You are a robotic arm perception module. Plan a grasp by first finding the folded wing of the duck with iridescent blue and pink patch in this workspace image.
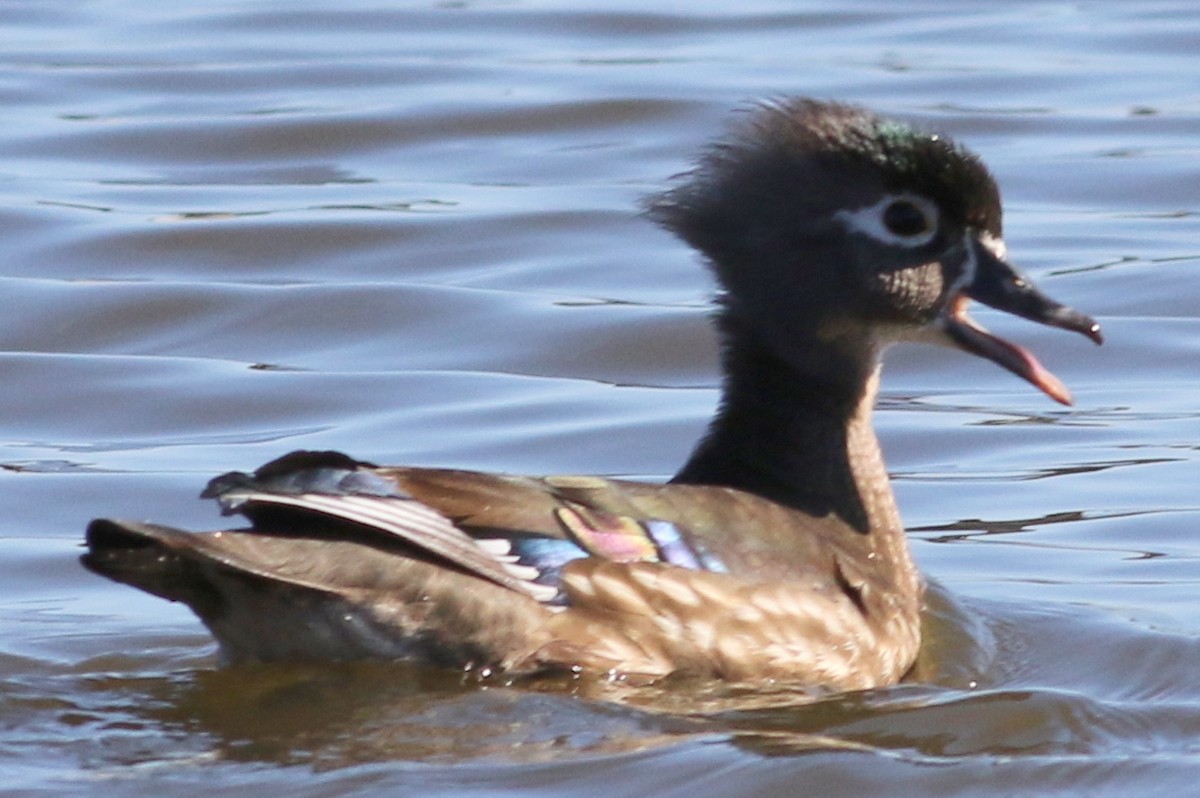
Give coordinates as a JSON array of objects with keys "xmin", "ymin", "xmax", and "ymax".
[{"xmin": 190, "ymin": 451, "xmax": 739, "ymax": 605}]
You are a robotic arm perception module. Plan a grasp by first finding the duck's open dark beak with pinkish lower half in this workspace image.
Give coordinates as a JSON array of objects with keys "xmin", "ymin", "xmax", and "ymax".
[{"xmin": 940, "ymin": 236, "xmax": 1104, "ymax": 404}]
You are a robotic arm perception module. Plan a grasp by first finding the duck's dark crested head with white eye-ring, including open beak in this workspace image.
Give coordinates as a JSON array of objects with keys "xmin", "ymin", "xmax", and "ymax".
[{"xmin": 650, "ymin": 100, "xmax": 1102, "ymax": 403}]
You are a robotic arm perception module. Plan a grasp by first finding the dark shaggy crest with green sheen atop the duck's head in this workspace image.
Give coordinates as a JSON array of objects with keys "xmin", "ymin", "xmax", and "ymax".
[{"xmin": 649, "ymin": 98, "xmax": 1002, "ymax": 273}]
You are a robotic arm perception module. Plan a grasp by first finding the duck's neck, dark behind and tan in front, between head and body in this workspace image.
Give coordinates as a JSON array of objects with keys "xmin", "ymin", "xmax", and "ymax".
[{"xmin": 672, "ymin": 313, "xmax": 902, "ymax": 534}]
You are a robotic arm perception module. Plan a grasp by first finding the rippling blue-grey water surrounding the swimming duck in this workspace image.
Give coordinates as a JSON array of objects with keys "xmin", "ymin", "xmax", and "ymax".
[{"xmin": 0, "ymin": 0, "xmax": 1200, "ymax": 798}]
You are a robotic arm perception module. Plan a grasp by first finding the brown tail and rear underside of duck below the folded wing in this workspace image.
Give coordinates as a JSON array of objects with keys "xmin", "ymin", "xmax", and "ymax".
[{"xmin": 82, "ymin": 518, "xmax": 551, "ymax": 668}]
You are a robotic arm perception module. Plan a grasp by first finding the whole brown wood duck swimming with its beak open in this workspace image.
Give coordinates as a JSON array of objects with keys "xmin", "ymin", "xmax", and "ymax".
[{"xmin": 83, "ymin": 98, "xmax": 1100, "ymax": 690}]
